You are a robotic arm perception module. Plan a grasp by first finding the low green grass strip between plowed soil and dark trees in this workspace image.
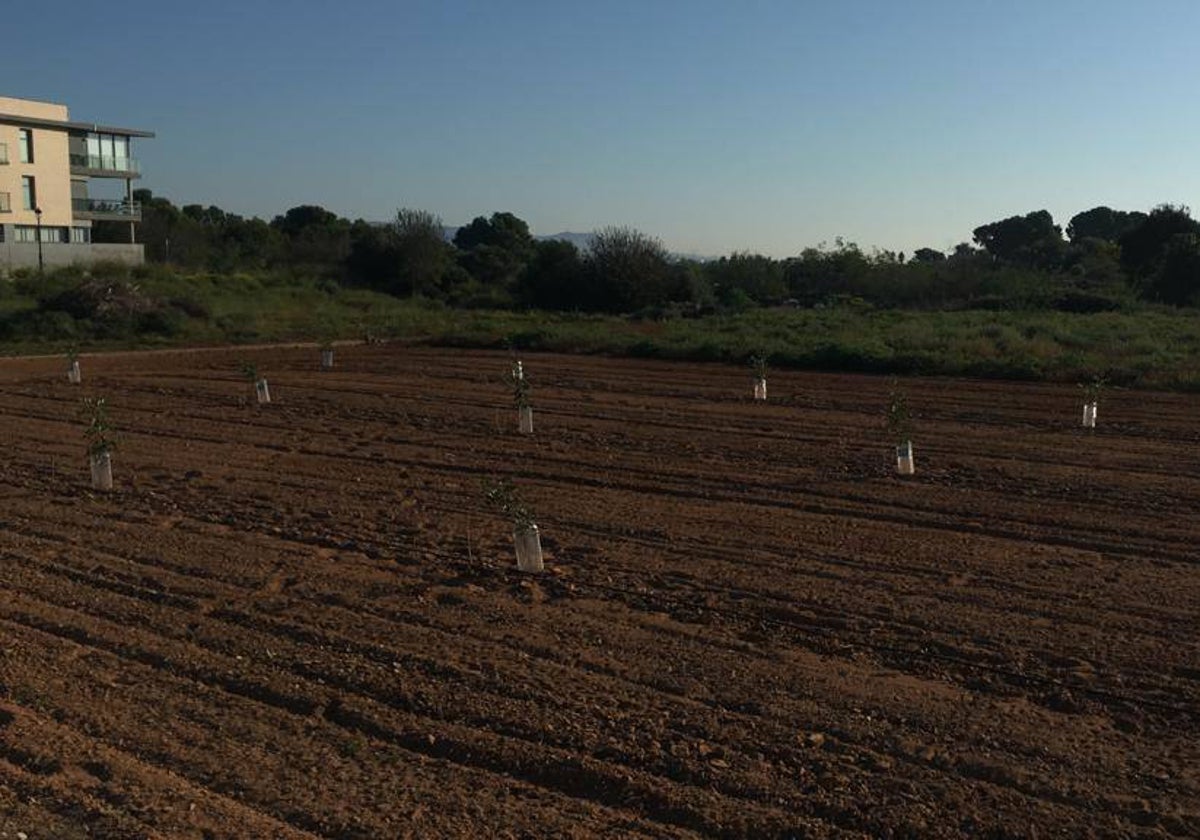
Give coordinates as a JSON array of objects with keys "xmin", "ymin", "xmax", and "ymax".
[{"xmin": 0, "ymin": 266, "xmax": 1200, "ymax": 390}]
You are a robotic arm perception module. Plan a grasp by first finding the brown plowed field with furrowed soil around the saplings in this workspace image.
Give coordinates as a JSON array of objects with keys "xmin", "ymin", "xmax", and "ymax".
[{"xmin": 0, "ymin": 344, "xmax": 1200, "ymax": 840}]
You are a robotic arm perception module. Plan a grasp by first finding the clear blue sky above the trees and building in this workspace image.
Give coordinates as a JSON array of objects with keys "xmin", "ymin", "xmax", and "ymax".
[{"xmin": 9, "ymin": 0, "xmax": 1200, "ymax": 257}]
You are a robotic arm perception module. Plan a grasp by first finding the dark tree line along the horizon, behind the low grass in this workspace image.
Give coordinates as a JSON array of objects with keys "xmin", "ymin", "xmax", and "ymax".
[{"xmin": 95, "ymin": 190, "xmax": 1200, "ymax": 316}]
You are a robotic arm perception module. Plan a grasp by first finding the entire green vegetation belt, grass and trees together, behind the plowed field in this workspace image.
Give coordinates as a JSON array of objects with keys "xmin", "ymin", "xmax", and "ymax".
[{"xmin": 7, "ymin": 191, "xmax": 1200, "ymax": 390}]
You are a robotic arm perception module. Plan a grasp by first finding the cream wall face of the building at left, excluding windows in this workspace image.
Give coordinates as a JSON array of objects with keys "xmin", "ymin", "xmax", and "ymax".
[{"xmin": 0, "ymin": 96, "xmax": 72, "ymax": 227}]
